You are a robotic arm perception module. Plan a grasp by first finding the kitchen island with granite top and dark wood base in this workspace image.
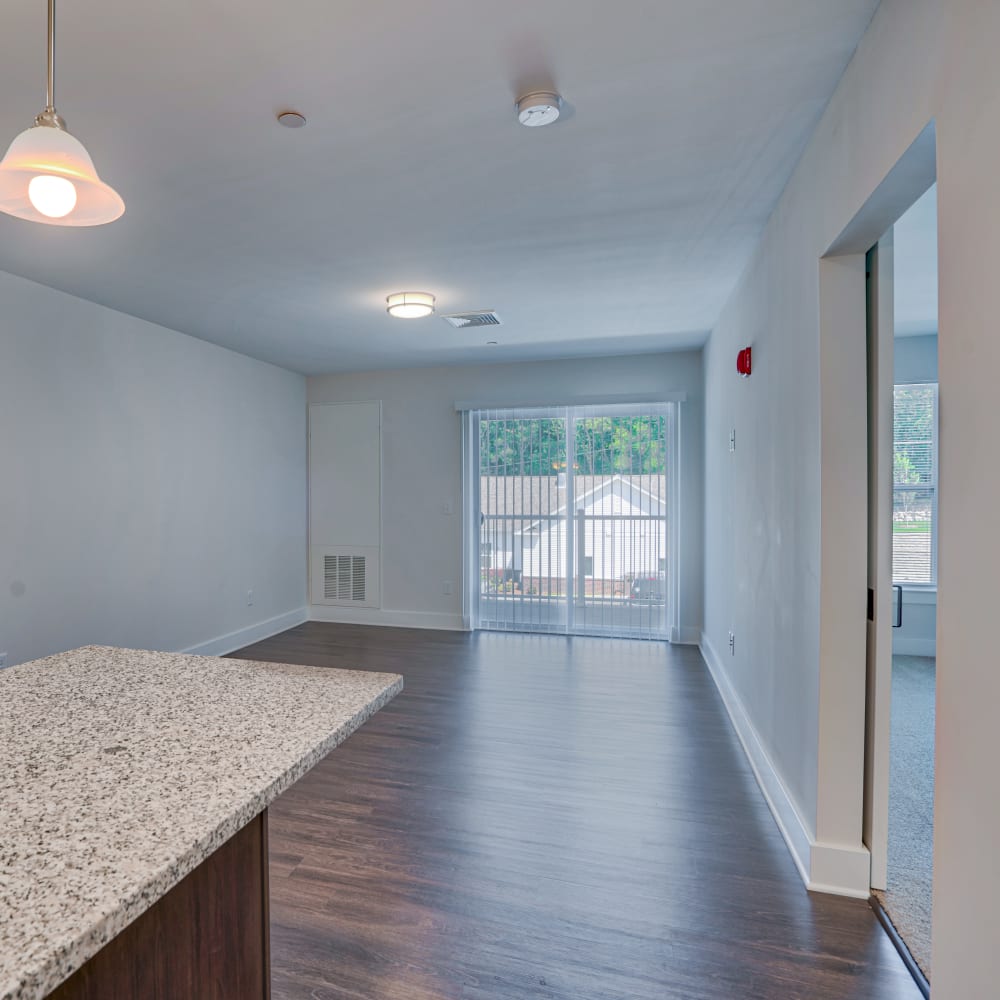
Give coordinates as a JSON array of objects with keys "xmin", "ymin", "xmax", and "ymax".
[{"xmin": 0, "ymin": 646, "xmax": 403, "ymax": 1000}]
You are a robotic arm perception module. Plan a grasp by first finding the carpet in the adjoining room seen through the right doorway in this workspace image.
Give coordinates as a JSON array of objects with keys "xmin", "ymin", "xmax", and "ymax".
[{"xmin": 875, "ymin": 656, "xmax": 935, "ymax": 980}]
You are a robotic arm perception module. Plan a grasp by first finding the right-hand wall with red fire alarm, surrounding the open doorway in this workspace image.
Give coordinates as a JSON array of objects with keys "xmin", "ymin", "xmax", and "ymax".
[{"xmin": 705, "ymin": 0, "xmax": 1000, "ymax": 998}]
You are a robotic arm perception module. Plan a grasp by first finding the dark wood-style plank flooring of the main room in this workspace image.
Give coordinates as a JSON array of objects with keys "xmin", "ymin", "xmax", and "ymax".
[{"xmin": 233, "ymin": 623, "xmax": 920, "ymax": 1000}]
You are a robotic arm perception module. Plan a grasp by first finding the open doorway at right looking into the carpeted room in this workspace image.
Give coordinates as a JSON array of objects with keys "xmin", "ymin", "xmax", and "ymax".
[{"xmin": 872, "ymin": 186, "xmax": 938, "ymax": 980}]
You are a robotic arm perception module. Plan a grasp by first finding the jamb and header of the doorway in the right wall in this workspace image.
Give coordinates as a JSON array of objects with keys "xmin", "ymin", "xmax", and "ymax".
[{"xmin": 809, "ymin": 122, "xmax": 936, "ymax": 897}]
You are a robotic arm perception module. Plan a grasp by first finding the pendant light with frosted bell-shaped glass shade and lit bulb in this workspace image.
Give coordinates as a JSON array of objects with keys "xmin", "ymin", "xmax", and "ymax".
[{"xmin": 0, "ymin": 0, "xmax": 125, "ymax": 226}]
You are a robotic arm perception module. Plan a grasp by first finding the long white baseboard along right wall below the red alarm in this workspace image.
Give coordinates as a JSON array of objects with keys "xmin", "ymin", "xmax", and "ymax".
[{"xmin": 699, "ymin": 632, "xmax": 813, "ymax": 888}]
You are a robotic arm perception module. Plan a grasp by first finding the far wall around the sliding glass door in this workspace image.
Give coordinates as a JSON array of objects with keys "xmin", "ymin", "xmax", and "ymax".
[{"xmin": 308, "ymin": 351, "xmax": 703, "ymax": 637}]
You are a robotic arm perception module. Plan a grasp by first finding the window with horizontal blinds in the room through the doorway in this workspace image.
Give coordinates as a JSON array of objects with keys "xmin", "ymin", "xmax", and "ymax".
[{"xmin": 892, "ymin": 383, "xmax": 938, "ymax": 586}]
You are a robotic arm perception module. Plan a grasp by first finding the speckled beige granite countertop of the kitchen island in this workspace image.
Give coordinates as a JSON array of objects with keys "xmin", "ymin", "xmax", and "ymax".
[{"xmin": 0, "ymin": 646, "xmax": 403, "ymax": 1000}]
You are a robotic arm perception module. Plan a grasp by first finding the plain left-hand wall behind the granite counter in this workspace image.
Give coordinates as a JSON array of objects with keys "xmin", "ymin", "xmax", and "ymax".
[{"xmin": 0, "ymin": 273, "xmax": 306, "ymax": 663}]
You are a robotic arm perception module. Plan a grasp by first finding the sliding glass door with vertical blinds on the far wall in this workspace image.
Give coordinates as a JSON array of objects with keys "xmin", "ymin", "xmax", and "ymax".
[{"xmin": 466, "ymin": 403, "xmax": 673, "ymax": 639}]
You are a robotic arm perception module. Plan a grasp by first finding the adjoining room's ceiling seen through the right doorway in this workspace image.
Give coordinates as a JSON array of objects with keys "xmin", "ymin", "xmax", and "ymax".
[{"xmin": 892, "ymin": 185, "xmax": 938, "ymax": 337}]
